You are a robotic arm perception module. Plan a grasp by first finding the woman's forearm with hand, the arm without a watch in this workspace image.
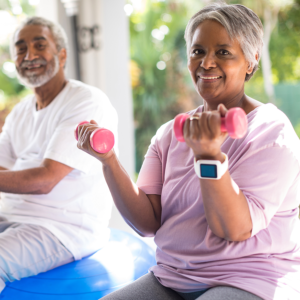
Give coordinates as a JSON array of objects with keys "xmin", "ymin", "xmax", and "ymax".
[{"xmin": 77, "ymin": 120, "xmax": 161, "ymax": 236}]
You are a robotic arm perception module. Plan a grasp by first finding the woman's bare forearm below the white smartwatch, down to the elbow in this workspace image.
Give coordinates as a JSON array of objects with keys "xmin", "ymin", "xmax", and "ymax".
[{"xmin": 200, "ymin": 171, "xmax": 252, "ymax": 241}]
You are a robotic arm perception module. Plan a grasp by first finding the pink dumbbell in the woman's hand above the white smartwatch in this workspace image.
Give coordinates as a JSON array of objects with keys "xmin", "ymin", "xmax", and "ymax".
[{"xmin": 173, "ymin": 107, "xmax": 248, "ymax": 142}]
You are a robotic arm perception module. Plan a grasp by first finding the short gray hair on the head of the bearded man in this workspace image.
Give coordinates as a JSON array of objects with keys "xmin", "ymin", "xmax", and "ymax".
[{"xmin": 10, "ymin": 17, "xmax": 68, "ymax": 57}]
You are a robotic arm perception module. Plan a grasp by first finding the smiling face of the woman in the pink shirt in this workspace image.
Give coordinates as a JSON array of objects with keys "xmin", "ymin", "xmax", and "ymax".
[{"xmin": 188, "ymin": 20, "xmax": 252, "ymax": 108}]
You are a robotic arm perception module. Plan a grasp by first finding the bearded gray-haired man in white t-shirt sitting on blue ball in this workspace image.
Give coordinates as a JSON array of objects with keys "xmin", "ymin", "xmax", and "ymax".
[{"xmin": 0, "ymin": 17, "xmax": 117, "ymax": 291}]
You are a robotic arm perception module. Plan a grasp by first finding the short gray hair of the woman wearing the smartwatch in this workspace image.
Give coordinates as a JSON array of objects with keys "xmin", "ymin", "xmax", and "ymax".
[{"xmin": 184, "ymin": 3, "xmax": 263, "ymax": 81}]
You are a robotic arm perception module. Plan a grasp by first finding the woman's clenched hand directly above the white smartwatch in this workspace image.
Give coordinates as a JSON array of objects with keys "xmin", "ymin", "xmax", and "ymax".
[{"xmin": 183, "ymin": 104, "xmax": 227, "ymax": 160}]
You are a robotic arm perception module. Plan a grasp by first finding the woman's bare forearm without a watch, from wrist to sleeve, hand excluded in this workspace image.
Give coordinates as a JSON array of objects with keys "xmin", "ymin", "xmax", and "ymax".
[{"xmin": 102, "ymin": 154, "xmax": 161, "ymax": 236}]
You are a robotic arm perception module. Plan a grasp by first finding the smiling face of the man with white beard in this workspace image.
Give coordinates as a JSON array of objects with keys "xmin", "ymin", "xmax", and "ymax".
[{"xmin": 13, "ymin": 25, "xmax": 63, "ymax": 88}]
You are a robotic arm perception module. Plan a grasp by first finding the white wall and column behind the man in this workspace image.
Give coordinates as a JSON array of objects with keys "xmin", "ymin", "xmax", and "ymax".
[{"xmin": 37, "ymin": 0, "xmax": 135, "ymax": 232}]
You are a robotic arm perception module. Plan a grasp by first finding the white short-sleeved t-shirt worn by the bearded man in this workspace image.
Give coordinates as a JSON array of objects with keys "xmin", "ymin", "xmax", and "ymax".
[{"xmin": 0, "ymin": 80, "xmax": 118, "ymax": 260}]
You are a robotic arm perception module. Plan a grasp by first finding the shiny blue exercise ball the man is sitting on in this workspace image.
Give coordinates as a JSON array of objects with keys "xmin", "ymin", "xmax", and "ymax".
[{"xmin": 0, "ymin": 229, "xmax": 156, "ymax": 300}]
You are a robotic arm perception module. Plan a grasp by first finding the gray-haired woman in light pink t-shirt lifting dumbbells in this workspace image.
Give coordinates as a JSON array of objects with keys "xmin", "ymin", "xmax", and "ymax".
[{"xmin": 78, "ymin": 4, "xmax": 300, "ymax": 300}]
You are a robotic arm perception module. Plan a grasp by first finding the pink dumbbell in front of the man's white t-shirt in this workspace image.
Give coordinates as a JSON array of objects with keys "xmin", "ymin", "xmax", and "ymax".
[{"xmin": 74, "ymin": 121, "xmax": 115, "ymax": 153}]
